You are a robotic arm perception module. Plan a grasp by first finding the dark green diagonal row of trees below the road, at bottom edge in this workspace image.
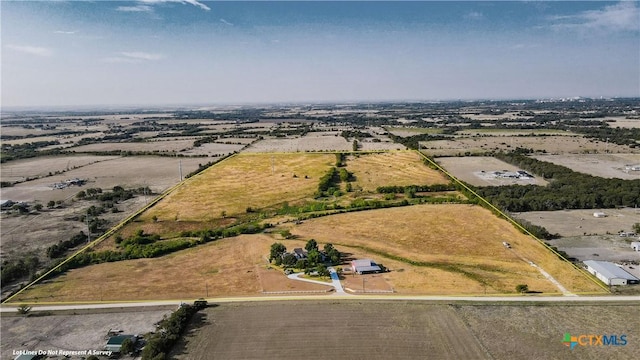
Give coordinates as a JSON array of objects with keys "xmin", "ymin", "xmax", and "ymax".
[{"xmin": 142, "ymin": 301, "xmax": 206, "ymax": 360}]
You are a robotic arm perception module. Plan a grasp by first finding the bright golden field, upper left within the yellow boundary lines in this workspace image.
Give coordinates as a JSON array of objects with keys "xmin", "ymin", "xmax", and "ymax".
[{"xmin": 141, "ymin": 154, "xmax": 335, "ymax": 221}]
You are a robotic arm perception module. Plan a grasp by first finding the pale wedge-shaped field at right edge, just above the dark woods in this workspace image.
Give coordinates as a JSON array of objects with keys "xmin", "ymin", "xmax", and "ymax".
[{"xmin": 533, "ymin": 154, "xmax": 640, "ymax": 180}]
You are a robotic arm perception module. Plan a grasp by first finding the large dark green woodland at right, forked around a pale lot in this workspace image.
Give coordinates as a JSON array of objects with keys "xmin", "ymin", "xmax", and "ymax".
[{"xmin": 477, "ymin": 153, "xmax": 640, "ymax": 212}]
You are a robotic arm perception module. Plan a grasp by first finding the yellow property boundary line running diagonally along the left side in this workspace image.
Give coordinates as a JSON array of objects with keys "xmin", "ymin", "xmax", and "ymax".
[{"xmin": 2, "ymin": 154, "xmax": 237, "ymax": 304}]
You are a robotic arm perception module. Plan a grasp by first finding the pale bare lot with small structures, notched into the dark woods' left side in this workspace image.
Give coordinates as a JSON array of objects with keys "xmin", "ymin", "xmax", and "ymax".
[{"xmin": 436, "ymin": 156, "xmax": 548, "ymax": 186}]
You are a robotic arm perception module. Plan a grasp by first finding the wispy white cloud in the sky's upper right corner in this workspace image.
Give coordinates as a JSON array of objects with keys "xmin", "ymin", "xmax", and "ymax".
[{"xmin": 549, "ymin": 1, "xmax": 640, "ymax": 31}]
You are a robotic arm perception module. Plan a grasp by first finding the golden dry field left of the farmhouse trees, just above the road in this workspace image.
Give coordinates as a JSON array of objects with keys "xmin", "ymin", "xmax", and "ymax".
[{"xmin": 10, "ymin": 235, "xmax": 272, "ymax": 302}]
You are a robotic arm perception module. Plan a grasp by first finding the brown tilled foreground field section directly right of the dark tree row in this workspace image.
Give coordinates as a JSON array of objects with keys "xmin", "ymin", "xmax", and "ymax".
[{"xmin": 171, "ymin": 302, "xmax": 489, "ymax": 360}]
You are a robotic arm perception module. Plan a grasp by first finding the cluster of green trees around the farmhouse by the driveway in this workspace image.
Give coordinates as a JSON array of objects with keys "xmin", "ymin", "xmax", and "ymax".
[{"xmin": 269, "ymin": 239, "xmax": 342, "ymax": 276}]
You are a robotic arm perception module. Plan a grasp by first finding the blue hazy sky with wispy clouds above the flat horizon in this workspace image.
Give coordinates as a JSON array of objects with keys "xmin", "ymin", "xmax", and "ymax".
[{"xmin": 0, "ymin": 0, "xmax": 640, "ymax": 107}]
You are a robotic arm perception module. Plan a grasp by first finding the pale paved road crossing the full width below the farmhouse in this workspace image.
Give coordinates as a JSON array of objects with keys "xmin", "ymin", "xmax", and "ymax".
[{"xmin": 0, "ymin": 296, "xmax": 640, "ymax": 313}]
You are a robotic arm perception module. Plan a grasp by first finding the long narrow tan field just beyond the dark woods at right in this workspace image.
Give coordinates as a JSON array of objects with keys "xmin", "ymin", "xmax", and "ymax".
[{"xmin": 421, "ymin": 135, "xmax": 640, "ymax": 156}]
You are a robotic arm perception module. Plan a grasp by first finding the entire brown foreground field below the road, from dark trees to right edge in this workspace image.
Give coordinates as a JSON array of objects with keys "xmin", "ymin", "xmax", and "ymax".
[{"xmin": 171, "ymin": 301, "xmax": 640, "ymax": 360}]
